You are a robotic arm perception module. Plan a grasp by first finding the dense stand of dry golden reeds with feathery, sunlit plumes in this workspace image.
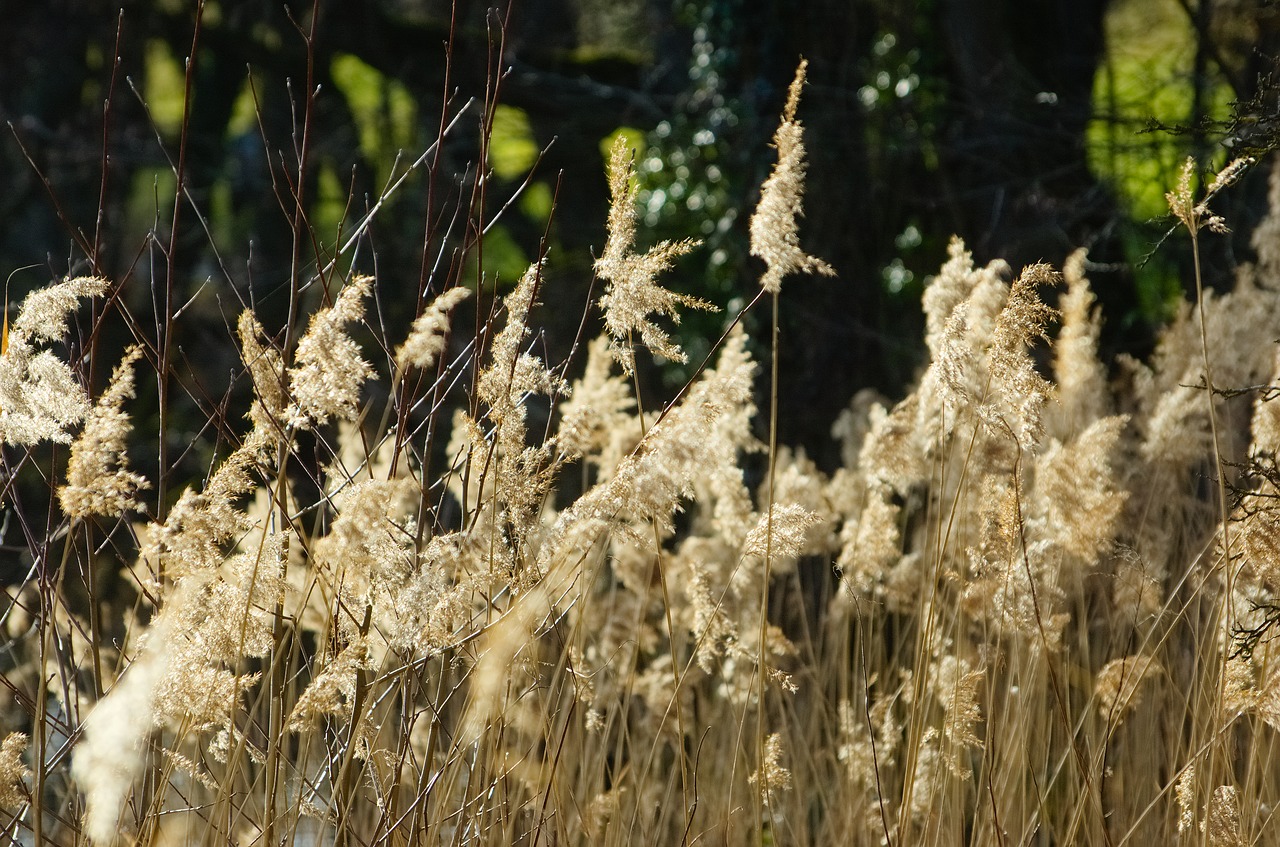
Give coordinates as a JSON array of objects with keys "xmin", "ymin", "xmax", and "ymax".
[{"xmin": 0, "ymin": 59, "xmax": 1280, "ymax": 847}]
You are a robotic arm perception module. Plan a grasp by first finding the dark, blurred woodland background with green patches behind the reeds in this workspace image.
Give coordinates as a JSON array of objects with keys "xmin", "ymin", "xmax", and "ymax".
[{"xmin": 0, "ymin": 0, "xmax": 1280, "ymax": 463}]
